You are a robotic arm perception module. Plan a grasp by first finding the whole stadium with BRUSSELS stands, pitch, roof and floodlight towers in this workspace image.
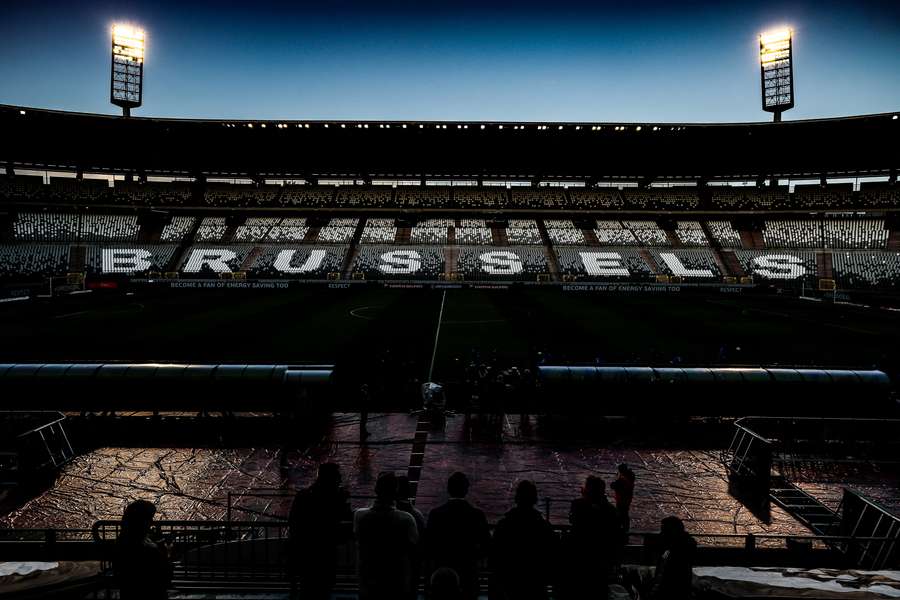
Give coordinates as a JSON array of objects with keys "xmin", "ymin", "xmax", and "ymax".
[{"xmin": 0, "ymin": 4, "xmax": 900, "ymax": 599}]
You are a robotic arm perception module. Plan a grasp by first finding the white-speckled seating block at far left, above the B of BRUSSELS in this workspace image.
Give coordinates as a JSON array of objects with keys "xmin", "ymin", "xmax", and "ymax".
[{"xmin": 13, "ymin": 213, "xmax": 140, "ymax": 241}]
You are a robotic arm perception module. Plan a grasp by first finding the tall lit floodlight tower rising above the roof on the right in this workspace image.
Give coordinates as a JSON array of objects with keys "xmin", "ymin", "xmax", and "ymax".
[{"xmin": 759, "ymin": 27, "xmax": 794, "ymax": 122}]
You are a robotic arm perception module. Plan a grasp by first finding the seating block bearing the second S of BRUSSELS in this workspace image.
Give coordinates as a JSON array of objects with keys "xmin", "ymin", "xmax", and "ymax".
[{"xmin": 456, "ymin": 246, "xmax": 550, "ymax": 281}]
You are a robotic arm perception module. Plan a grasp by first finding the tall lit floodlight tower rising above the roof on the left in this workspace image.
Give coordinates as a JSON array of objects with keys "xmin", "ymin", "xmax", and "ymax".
[{"xmin": 109, "ymin": 24, "xmax": 144, "ymax": 117}]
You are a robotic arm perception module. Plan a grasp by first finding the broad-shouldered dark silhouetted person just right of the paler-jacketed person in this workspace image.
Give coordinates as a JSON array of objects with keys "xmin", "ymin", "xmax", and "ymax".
[{"xmin": 425, "ymin": 472, "xmax": 491, "ymax": 599}]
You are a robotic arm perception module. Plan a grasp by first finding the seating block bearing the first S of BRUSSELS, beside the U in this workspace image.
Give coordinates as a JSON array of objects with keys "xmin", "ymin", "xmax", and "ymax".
[{"xmin": 351, "ymin": 245, "xmax": 444, "ymax": 280}]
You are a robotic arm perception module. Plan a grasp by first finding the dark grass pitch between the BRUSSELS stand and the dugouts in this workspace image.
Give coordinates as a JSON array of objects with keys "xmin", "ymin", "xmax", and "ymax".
[{"xmin": 0, "ymin": 288, "xmax": 900, "ymax": 378}]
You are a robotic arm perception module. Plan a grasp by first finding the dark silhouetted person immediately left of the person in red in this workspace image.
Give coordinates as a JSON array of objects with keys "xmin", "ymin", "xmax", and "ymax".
[{"xmin": 560, "ymin": 475, "xmax": 624, "ymax": 598}]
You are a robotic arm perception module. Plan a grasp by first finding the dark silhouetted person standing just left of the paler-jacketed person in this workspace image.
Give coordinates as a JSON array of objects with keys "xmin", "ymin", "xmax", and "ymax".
[{"xmin": 288, "ymin": 463, "xmax": 353, "ymax": 600}]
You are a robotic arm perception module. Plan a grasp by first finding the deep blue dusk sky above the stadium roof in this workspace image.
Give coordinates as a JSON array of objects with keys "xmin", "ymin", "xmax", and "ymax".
[{"xmin": 0, "ymin": 0, "xmax": 900, "ymax": 122}]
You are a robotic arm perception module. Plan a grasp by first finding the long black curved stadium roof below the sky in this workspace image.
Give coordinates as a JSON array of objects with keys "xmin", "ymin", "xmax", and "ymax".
[{"xmin": 0, "ymin": 105, "xmax": 900, "ymax": 181}]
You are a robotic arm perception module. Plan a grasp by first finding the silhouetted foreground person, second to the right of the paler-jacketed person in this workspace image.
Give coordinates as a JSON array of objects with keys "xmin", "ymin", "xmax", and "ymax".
[{"xmin": 491, "ymin": 481, "xmax": 556, "ymax": 600}]
